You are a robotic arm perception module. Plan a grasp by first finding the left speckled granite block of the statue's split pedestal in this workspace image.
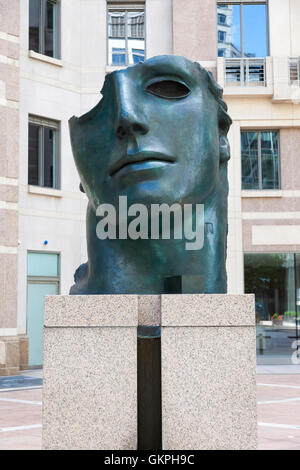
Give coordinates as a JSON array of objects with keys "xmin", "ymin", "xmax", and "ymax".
[{"xmin": 43, "ymin": 295, "xmax": 138, "ymax": 450}]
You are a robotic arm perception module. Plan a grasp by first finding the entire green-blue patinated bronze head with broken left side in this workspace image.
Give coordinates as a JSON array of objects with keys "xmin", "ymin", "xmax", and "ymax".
[{"xmin": 70, "ymin": 56, "xmax": 231, "ymax": 294}]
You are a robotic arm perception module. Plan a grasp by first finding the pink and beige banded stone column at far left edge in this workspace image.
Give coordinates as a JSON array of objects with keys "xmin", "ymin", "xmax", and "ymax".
[{"xmin": 0, "ymin": 0, "xmax": 27, "ymax": 375}]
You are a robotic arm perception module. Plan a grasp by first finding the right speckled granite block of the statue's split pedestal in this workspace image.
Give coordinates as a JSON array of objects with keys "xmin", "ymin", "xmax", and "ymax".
[{"xmin": 161, "ymin": 294, "xmax": 257, "ymax": 450}]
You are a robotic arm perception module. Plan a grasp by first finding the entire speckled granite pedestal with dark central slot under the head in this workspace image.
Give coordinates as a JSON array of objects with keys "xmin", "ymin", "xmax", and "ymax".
[{"xmin": 43, "ymin": 294, "xmax": 256, "ymax": 450}]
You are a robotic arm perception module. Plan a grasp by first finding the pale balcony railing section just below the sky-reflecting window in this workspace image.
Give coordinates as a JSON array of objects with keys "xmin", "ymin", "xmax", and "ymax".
[{"xmin": 224, "ymin": 57, "xmax": 266, "ymax": 87}]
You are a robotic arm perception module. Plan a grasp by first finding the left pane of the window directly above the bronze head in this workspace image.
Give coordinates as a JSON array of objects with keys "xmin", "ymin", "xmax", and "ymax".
[{"xmin": 108, "ymin": 11, "xmax": 126, "ymax": 66}]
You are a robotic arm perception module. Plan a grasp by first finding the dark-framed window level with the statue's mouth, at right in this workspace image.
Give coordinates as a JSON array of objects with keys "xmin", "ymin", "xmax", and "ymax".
[{"xmin": 241, "ymin": 131, "xmax": 279, "ymax": 189}]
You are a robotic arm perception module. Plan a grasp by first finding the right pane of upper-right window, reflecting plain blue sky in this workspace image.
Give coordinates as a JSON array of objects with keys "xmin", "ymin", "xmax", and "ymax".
[{"xmin": 243, "ymin": 5, "xmax": 267, "ymax": 57}]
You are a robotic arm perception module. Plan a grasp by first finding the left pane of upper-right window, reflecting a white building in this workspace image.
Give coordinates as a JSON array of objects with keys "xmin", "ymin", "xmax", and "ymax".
[{"xmin": 217, "ymin": 5, "xmax": 242, "ymax": 57}]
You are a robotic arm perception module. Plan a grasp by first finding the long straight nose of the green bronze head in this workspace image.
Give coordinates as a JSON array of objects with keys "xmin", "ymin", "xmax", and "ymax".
[{"xmin": 115, "ymin": 72, "xmax": 149, "ymax": 139}]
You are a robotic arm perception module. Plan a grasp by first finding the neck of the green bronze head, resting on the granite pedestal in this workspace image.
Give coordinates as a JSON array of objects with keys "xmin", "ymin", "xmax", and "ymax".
[{"xmin": 74, "ymin": 180, "xmax": 227, "ymax": 294}]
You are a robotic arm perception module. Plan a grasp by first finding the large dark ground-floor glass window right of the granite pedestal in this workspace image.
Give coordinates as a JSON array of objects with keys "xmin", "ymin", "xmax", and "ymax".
[{"xmin": 244, "ymin": 253, "xmax": 296, "ymax": 364}]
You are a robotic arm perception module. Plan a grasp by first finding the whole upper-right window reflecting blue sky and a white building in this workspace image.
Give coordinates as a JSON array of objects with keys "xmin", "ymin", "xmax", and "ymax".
[{"xmin": 217, "ymin": 2, "xmax": 268, "ymax": 58}]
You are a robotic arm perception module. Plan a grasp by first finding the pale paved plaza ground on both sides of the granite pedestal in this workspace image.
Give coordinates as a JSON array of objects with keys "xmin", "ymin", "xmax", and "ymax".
[{"xmin": 0, "ymin": 366, "xmax": 300, "ymax": 450}]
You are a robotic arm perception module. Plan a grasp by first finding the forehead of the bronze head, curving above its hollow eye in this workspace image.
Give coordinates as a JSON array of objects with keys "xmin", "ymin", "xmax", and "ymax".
[{"xmin": 103, "ymin": 55, "xmax": 203, "ymax": 89}]
